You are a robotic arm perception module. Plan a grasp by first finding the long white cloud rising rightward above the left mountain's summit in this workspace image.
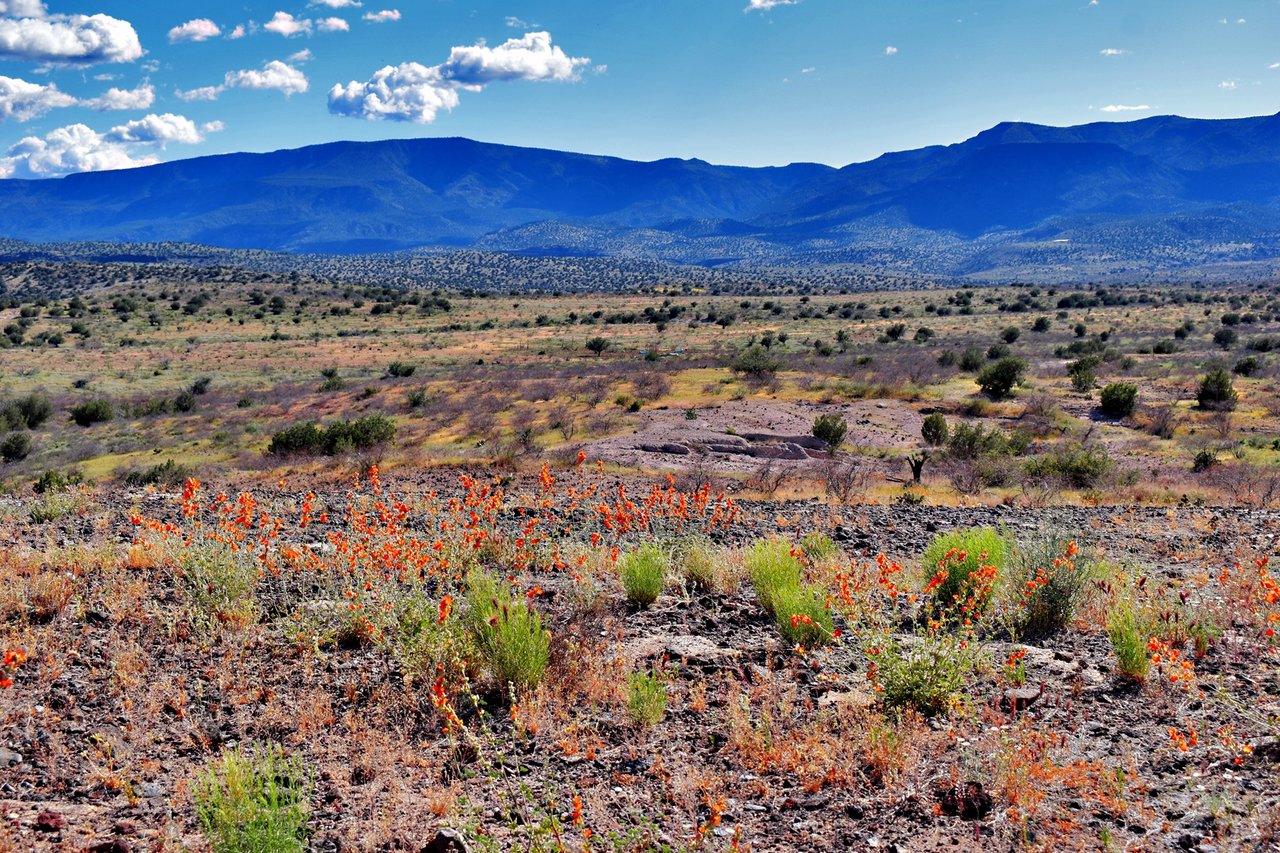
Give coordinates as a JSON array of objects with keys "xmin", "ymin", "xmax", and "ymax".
[{"xmin": 329, "ymin": 32, "xmax": 591, "ymax": 124}]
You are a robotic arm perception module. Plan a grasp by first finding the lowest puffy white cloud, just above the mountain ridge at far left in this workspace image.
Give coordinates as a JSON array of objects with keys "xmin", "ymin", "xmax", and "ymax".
[{"xmin": 0, "ymin": 113, "xmax": 221, "ymax": 178}]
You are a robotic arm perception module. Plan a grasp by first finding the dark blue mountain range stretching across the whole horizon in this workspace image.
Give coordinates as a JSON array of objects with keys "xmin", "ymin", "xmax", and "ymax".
[{"xmin": 0, "ymin": 114, "xmax": 1280, "ymax": 278}]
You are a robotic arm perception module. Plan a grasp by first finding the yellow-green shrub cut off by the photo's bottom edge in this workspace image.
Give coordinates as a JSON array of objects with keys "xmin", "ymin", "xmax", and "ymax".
[{"xmin": 193, "ymin": 747, "xmax": 310, "ymax": 853}]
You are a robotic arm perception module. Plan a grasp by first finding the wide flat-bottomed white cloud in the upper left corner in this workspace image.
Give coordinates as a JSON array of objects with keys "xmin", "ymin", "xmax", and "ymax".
[{"xmin": 0, "ymin": 14, "xmax": 142, "ymax": 65}]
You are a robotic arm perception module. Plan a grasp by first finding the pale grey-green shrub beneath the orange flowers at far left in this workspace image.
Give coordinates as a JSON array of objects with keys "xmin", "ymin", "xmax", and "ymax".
[{"xmin": 177, "ymin": 544, "xmax": 257, "ymax": 631}]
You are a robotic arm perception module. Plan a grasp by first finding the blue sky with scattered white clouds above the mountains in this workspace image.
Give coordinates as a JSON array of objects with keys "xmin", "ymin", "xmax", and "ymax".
[{"xmin": 0, "ymin": 0, "xmax": 1280, "ymax": 178}]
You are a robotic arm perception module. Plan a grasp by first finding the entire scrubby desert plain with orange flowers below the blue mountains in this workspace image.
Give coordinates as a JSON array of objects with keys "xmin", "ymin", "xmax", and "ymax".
[{"xmin": 0, "ymin": 264, "xmax": 1280, "ymax": 853}]
